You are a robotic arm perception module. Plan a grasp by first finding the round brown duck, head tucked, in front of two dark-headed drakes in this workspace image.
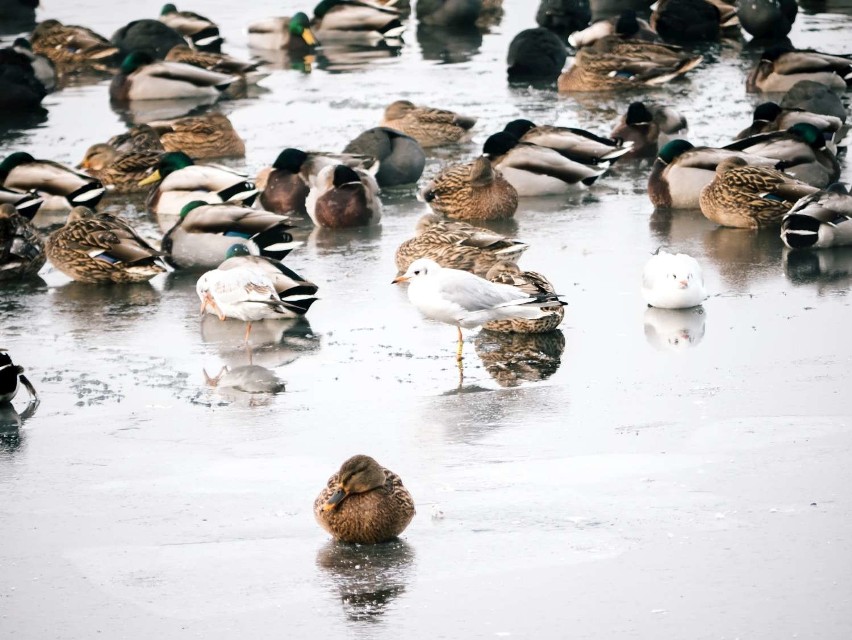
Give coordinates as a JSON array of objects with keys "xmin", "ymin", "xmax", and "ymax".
[{"xmin": 419, "ymin": 156, "xmax": 518, "ymax": 220}]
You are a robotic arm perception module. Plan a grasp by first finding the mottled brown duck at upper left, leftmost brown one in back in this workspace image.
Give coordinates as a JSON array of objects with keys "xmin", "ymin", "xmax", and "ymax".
[{"xmin": 30, "ymin": 20, "xmax": 121, "ymax": 70}]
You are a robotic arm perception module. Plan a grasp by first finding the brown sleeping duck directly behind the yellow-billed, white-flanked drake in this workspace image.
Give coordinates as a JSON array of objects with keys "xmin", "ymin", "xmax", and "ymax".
[{"xmin": 149, "ymin": 113, "xmax": 246, "ymax": 158}]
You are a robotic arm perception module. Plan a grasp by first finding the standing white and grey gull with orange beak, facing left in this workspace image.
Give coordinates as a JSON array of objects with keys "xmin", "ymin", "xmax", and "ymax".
[{"xmin": 392, "ymin": 258, "xmax": 565, "ymax": 363}]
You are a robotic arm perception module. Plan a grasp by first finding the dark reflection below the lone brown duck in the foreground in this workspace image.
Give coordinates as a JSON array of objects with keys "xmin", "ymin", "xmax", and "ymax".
[{"xmin": 317, "ymin": 540, "xmax": 415, "ymax": 622}]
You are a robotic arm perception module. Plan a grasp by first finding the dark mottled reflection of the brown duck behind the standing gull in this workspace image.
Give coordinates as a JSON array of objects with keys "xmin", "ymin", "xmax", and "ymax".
[{"xmin": 474, "ymin": 329, "xmax": 565, "ymax": 387}]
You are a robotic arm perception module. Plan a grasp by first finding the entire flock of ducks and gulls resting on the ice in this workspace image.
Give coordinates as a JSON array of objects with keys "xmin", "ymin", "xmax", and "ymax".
[{"xmin": 0, "ymin": 0, "xmax": 852, "ymax": 543}]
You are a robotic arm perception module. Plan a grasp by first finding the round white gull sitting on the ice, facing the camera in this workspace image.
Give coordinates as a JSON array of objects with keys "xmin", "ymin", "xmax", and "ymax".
[{"xmin": 642, "ymin": 249, "xmax": 707, "ymax": 309}]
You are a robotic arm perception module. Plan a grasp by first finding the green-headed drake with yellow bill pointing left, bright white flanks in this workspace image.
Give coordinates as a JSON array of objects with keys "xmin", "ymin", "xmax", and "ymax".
[{"xmin": 139, "ymin": 151, "xmax": 257, "ymax": 231}]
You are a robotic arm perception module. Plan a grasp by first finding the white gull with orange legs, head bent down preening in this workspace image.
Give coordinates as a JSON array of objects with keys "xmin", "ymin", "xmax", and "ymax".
[{"xmin": 195, "ymin": 260, "xmax": 314, "ymax": 344}]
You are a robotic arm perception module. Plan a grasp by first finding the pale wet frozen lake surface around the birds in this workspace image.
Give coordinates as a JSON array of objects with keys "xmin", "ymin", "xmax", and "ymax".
[{"xmin": 0, "ymin": 0, "xmax": 852, "ymax": 640}]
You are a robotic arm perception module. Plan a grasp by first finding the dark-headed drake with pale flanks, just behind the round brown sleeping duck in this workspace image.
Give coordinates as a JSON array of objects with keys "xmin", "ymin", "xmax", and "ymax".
[{"xmin": 482, "ymin": 131, "xmax": 609, "ymax": 196}]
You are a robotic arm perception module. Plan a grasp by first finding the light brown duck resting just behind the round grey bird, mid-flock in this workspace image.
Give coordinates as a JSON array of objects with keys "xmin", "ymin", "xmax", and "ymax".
[{"xmin": 379, "ymin": 100, "xmax": 476, "ymax": 147}]
